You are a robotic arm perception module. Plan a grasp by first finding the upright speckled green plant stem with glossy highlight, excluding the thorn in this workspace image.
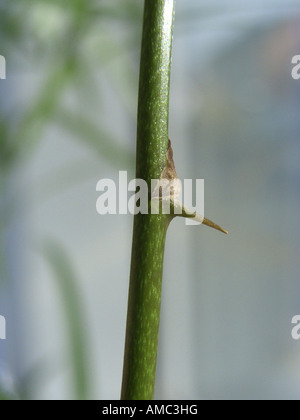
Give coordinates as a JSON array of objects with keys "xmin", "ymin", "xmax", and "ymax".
[{"xmin": 121, "ymin": 0, "xmax": 174, "ymax": 400}]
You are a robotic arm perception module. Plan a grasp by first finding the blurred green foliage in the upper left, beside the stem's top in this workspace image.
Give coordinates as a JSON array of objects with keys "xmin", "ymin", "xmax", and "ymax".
[{"xmin": 0, "ymin": 0, "xmax": 141, "ymax": 174}]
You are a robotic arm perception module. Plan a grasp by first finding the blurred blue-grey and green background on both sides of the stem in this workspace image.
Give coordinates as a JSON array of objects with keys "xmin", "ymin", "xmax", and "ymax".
[{"xmin": 0, "ymin": 0, "xmax": 300, "ymax": 399}]
